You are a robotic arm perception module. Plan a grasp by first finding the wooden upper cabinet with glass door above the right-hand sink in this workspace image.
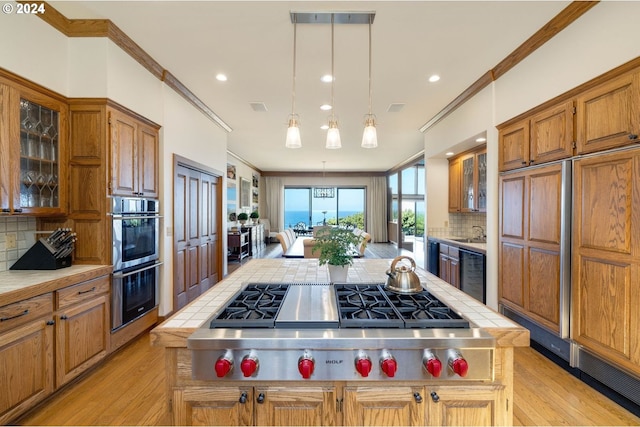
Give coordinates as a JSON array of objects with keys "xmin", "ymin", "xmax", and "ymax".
[{"xmin": 449, "ymin": 145, "xmax": 487, "ymax": 212}]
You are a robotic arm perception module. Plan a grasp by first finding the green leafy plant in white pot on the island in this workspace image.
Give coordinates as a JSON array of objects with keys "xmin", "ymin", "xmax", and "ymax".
[{"xmin": 311, "ymin": 227, "xmax": 362, "ymax": 283}]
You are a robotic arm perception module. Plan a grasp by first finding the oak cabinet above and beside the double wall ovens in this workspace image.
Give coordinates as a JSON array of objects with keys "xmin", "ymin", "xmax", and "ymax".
[{"xmin": 66, "ymin": 99, "xmax": 159, "ymax": 264}]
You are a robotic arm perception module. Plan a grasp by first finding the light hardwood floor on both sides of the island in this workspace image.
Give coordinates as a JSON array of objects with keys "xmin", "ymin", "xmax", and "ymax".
[{"xmin": 17, "ymin": 333, "xmax": 640, "ymax": 426}]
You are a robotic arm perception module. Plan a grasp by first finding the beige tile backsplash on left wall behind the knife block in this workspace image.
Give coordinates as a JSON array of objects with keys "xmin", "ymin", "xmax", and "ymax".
[{"xmin": 0, "ymin": 216, "xmax": 36, "ymax": 271}]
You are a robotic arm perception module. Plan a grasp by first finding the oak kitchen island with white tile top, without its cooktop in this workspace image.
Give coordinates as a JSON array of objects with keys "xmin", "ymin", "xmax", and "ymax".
[{"xmin": 151, "ymin": 259, "xmax": 529, "ymax": 425}]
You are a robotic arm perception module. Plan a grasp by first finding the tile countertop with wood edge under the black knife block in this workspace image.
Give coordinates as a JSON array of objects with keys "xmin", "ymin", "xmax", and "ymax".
[{"xmin": 0, "ymin": 265, "xmax": 112, "ymax": 306}]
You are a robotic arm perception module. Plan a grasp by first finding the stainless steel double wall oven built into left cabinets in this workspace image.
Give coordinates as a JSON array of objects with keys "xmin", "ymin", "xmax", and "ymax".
[{"xmin": 111, "ymin": 197, "xmax": 162, "ymax": 331}]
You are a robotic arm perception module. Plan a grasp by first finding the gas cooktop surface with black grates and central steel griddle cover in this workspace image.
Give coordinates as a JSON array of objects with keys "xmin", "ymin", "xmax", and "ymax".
[{"xmin": 210, "ymin": 283, "xmax": 469, "ymax": 329}]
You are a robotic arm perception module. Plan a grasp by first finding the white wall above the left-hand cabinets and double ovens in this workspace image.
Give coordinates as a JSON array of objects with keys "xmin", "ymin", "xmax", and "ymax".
[{"xmin": 0, "ymin": 14, "xmax": 227, "ymax": 315}]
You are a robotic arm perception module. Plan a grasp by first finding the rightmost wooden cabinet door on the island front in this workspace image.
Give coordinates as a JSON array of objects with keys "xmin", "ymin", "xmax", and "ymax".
[{"xmin": 425, "ymin": 385, "xmax": 504, "ymax": 426}]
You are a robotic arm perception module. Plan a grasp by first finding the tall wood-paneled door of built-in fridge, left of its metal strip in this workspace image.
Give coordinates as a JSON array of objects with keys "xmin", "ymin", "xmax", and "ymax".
[{"xmin": 498, "ymin": 163, "xmax": 568, "ymax": 332}]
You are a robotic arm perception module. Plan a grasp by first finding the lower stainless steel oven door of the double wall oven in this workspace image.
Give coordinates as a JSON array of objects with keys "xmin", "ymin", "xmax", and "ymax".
[{"xmin": 111, "ymin": 262, "xmax": 162, "ymax": 331}]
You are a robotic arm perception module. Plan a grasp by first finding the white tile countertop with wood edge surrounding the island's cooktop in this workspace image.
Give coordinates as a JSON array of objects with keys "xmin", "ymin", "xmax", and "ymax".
[{"xmin": 152, "ymin": 258, "xmax": 529, "ymax": 347}]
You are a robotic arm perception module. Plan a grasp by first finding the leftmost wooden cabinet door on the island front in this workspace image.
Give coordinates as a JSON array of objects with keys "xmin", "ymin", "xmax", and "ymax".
[{"xmin": 173, "ymin": 387, "xmax": 254, "ymax": 426}]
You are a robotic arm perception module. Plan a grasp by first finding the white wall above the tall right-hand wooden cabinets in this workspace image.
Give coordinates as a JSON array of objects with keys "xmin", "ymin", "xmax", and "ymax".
[{"xmin": 424, "ymin": 2, "xmax": 640, "ymax": 308}]
